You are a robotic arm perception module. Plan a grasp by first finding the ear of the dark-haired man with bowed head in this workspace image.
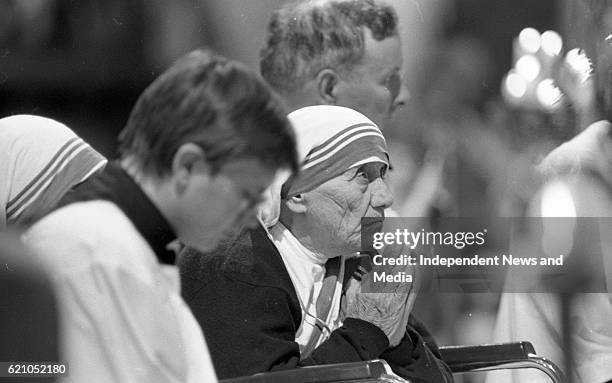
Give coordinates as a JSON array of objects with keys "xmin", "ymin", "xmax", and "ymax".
[{"xmin": 172, "ymin": 142, "xmax": 211, "ymax": 194}]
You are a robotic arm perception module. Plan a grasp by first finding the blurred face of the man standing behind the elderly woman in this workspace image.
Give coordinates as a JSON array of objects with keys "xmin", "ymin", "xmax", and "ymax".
[{"xmin": 337, "ymin": 28, "xmax": 408, "ymax": 127}]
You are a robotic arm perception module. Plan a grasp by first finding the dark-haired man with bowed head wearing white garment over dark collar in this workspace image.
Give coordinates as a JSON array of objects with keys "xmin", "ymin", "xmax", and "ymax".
[{"xmin": 27, "ymin": 51, "xmax": 297, "ymax": 383}]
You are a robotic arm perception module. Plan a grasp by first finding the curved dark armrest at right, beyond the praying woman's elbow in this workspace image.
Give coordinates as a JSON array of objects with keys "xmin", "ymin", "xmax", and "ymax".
[{"xmin": 440, "ymin": 342, "xmax": 565, "ymax": 383}]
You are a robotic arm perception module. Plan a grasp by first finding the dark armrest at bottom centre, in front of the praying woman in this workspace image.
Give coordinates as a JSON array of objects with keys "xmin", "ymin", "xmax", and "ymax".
[{"xmin": 219, "ymin": 360, "xmax": 406, "ymax": 383}]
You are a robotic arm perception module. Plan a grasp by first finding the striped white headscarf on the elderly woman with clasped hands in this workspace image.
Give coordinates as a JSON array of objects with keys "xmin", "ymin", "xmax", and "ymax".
[{"xmin": 259, "ymin": 105, "xmax": 389, "ymax": 227}]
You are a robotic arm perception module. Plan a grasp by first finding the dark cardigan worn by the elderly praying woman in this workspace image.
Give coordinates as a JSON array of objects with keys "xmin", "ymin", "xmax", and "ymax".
[{"xmin": 179, "ymin": 227, "xmax": 452, "ymax": 382}]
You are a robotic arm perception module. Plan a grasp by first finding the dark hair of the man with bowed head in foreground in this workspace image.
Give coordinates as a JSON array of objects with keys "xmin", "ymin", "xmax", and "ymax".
[{"xmin": 119, "ymin": 50, "xmax": 298, "ymax": 176}]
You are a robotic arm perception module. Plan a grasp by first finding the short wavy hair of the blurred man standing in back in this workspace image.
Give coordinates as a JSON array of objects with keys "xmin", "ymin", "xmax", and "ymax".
[{"xmin": 259, "ymin": 0, "xmax": 397, "ymax": 92}]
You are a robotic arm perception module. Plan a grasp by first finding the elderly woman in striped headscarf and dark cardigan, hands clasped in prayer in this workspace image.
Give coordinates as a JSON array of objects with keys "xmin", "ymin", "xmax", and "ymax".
[{"xmin": 180, "ymin": 105, "xmax": 452, "ymax": 382}]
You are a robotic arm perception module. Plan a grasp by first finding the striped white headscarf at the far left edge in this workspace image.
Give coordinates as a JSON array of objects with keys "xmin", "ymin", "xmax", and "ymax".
[{"xmin": 0, "ymin": 115, "xmax": 106, "ymax": 230}]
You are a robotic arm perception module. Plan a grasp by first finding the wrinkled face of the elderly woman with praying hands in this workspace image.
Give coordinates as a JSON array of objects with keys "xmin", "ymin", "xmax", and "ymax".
[{"xmin": 302, "ymin": 162, "xmax": 393, "ymax": 257}]
